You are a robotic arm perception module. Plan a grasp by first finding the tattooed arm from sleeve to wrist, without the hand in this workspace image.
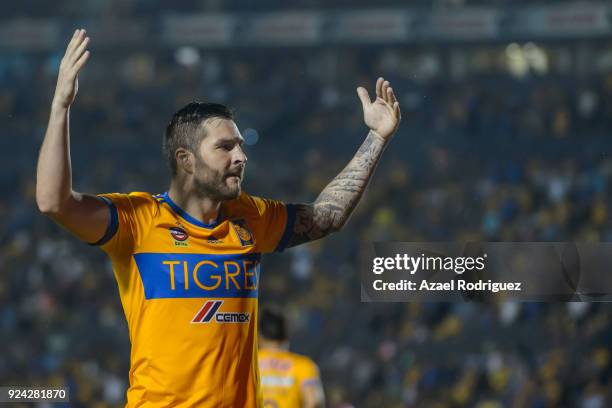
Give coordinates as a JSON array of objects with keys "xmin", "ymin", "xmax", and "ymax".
[{"xmin": 287, "ymin": 132, "xmax": 385, "ymax": 247}]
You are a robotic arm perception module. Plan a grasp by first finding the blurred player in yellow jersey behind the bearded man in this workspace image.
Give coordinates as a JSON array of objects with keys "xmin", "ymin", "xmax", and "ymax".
[{"xmin": 259, "ymin": 308, "xmax": 325, "ymax": 408}]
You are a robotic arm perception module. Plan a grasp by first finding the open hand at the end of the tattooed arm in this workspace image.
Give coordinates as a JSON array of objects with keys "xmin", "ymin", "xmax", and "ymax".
[{"xmin": 357, "ymin": 78, "xmax": 401, "ymax": 141}]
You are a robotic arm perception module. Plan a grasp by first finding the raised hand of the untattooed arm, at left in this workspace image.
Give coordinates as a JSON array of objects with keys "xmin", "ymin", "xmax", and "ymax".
[{"xmin": 53, "ymin": 29, "xmax": 90, "ymax": 109}]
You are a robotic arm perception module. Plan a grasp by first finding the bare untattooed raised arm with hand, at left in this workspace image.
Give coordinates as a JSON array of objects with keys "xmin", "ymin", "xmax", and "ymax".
[{"xmin": 36, "ymin": 30, "xmax": 110, "ymax": 242}]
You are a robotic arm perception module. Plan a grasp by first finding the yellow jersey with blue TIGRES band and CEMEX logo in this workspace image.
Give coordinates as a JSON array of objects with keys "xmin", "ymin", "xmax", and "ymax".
[{"xmin": 96, "ymin": 193, "xmax": 294, "ymax": 408}]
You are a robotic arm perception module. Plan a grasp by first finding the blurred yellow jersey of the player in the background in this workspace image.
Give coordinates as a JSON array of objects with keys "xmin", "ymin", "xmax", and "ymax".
[{"xmin": 259, "ymin": 348, "xmax": 321, "ymax": 408}]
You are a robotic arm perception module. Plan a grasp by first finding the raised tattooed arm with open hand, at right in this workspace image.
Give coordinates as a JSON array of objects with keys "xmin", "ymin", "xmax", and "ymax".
[{"xmin": 287, "ymin": 78, "xmax": 401, "ymax": 247}]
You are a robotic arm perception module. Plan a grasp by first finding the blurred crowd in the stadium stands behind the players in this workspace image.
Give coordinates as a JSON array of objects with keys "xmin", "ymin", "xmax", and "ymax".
[{"xmin": 0, "ymin": 39, "xmax": 612, "ymax": 408}]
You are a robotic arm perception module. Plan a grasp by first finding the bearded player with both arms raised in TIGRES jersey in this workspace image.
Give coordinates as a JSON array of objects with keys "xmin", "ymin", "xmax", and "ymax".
[{"xmin": 36, "ymin": 30, "xmax": 400, "ymax": 407}]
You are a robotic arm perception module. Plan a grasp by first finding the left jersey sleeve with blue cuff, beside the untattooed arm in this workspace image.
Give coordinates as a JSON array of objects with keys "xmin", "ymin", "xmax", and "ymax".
[{"xmin": 92, "ymin": 193, "xmax": 155, "ymax": 258}]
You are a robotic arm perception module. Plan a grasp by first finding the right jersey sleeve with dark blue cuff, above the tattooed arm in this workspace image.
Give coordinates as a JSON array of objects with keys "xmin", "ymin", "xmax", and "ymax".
[{"xmin": 248, "ymin": 196, "xmax": 295, "ymax": 252}]
